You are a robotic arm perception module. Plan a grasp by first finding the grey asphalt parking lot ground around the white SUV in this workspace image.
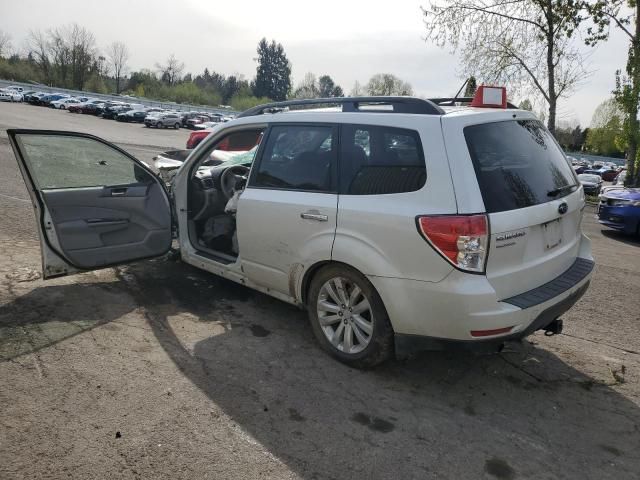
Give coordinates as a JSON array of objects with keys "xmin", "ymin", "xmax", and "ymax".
[{"xmin": 0, "ymin": 104, "xmax": 640, "ymax": 480}]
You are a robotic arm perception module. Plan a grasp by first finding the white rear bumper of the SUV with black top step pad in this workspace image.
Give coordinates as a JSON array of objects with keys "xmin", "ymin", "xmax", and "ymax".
[{"xmin": 369, "ymin": 237, "xmax": 594, "ymax": 350}]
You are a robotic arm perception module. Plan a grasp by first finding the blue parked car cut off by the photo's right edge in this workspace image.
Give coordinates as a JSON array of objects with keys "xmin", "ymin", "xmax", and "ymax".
[{"xmin": 598, "ymin": 188, "xmax": 640, "ymax": 235}]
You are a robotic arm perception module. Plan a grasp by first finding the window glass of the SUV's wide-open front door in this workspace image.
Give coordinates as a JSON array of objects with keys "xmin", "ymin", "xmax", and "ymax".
[{"xmin": 17, "ymin": 135, "xmax": 152, "ymax": 189}]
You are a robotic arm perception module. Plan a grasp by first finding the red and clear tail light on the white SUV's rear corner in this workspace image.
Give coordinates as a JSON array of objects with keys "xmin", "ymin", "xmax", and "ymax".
[{"xmin": 417, "ymin": 215, "xmax": 489, "ymax": 273}]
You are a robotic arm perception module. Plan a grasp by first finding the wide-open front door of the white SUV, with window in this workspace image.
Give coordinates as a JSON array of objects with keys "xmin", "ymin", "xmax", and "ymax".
[{"xmin": 7, "ymin": 130, "xmax": 172, "ymax": 279}]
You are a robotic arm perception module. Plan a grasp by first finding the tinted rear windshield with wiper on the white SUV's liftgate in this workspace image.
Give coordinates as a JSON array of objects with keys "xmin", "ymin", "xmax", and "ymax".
[{"xmin": 464, "ymin": 120, "xmax": 578, "ymax": 213}]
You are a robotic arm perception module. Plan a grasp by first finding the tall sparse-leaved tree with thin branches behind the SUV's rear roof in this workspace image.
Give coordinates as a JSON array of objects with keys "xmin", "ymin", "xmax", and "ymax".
[{"xmin": 422, "ymin": 0, "xmax": 604, "ymax": 133}]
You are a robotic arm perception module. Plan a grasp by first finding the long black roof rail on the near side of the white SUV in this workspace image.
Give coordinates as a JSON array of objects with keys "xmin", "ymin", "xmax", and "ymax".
[{"xmin": 236, "ymin": 97, "xmax": 445, "ymax": 118}]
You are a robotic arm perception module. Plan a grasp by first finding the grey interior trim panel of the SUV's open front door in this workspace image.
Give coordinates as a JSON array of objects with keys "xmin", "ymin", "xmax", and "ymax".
[{"xmin": 41, "ymin": 183, "xmax": 171, "ymax": 268}]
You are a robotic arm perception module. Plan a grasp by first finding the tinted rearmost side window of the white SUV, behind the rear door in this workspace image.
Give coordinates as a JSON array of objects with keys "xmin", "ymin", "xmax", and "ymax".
[{"xmin": 340, "ymin": 125, "xmax": 427, "ymax": 195}]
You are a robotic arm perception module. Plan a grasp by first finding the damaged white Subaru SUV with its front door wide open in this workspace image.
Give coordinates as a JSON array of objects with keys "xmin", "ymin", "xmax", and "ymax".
[{"xmin": 8, "ymin": 87, "xmax": 594, "ymax": 367}]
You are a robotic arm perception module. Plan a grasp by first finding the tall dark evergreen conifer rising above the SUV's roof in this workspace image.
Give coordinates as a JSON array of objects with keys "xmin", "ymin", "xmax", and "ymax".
[{"xmin": 253, "ymin": 38, "xmax": 291, "ymax": 101}]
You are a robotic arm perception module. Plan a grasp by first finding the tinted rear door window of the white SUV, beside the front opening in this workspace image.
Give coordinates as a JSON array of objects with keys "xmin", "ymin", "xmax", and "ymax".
[{"xmin": 252, "ymin": 125, "xmax": 336, "ymax": 192}]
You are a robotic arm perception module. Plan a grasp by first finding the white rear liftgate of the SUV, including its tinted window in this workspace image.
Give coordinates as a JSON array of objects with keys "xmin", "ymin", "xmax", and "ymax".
[{"xmin": 443, "ymin": 112, "xmax": 584, "ymax": 299}]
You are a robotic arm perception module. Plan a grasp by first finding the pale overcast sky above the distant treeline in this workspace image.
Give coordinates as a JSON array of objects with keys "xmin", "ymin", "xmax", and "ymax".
[{"xmin": 0, "ymin": 0, "xmax": 627, "ymax": 126}]
